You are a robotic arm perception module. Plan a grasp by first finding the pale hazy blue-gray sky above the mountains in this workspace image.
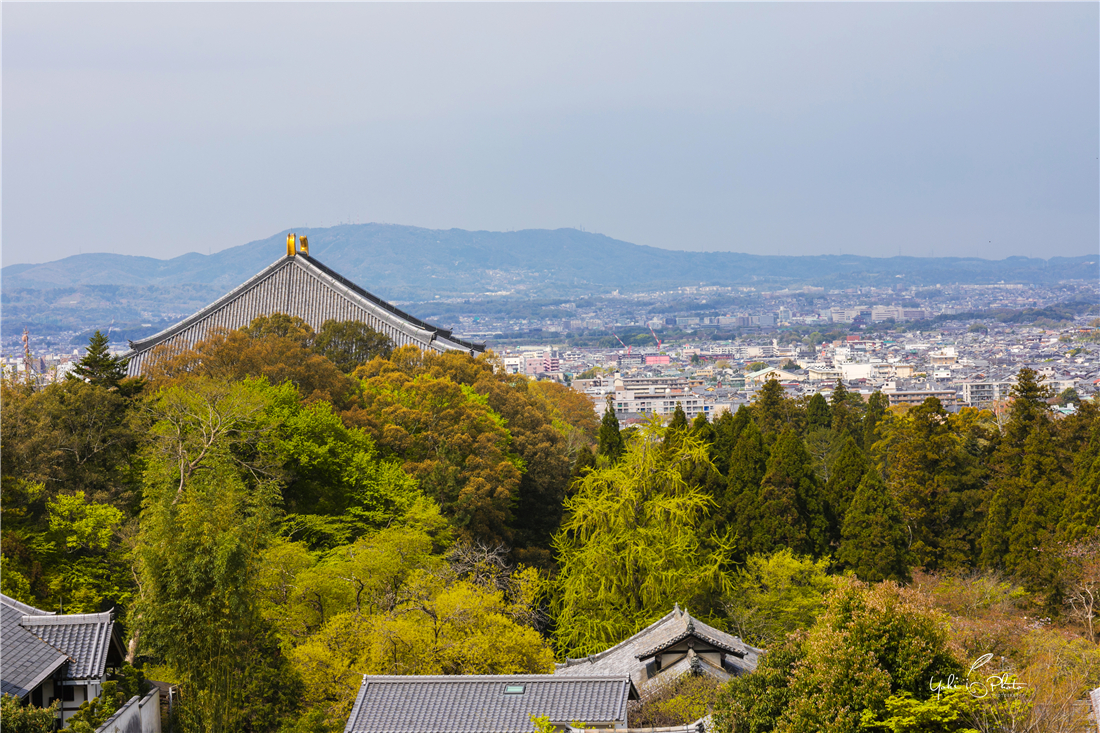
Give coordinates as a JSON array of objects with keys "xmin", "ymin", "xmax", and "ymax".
[{"xmin": 2, "ymin": 2, "xmax": 1100, "ymax": 264}]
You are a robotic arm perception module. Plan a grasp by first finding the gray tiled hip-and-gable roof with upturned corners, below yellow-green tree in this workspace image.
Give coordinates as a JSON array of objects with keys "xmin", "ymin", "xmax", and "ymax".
[{"xmin": 554, "ymin": 606, "xmax": 762, "ymax": 688}]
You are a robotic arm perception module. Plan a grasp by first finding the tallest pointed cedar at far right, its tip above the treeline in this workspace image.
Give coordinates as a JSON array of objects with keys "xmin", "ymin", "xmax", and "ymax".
[{"xmin": 981, "ymin": 368, "xmax": 1067, "ymax": 588}]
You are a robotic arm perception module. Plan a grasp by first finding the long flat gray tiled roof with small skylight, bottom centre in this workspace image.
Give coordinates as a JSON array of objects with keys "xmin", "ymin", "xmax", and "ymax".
[{"xmin": 344, "ymin": 675, "xmax": 634, "ymax": 733}]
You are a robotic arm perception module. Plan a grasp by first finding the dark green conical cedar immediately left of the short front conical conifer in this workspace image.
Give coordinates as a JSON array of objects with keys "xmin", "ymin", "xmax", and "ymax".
[{"xmin": 743, "ymin": 430, "xmax": 827, "ymax": 557}]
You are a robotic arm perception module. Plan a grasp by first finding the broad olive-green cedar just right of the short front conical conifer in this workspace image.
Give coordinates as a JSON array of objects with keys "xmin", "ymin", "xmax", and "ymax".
[{"xmin": 887, "ymin": 397, "xmax": 986, "ymax": 570}]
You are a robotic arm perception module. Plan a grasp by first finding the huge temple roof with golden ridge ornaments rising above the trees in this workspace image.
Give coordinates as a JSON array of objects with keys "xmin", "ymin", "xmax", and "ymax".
[{"xmin": 125, "ymin": 234, "xmax": 485, "ymax": 376}]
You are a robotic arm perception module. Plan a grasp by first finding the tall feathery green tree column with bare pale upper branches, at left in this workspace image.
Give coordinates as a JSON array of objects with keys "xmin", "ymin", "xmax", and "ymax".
[{"xmin": 135, "ymin": 379, "xmax": 300, "ymax": 731}]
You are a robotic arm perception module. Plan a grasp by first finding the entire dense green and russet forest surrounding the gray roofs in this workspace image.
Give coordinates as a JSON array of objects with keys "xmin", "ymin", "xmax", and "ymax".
[{"xmin": 0, "ymin": 315, "xmax": 1100, "ymax": 733}]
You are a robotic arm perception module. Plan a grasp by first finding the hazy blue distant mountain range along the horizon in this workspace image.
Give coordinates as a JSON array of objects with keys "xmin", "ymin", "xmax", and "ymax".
[{"xmin": 0, "ymin": 223, "xmax": 1100, "ymax": 335}]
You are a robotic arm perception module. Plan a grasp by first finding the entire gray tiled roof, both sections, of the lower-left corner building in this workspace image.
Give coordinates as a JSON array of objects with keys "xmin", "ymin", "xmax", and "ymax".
[{"xmin": 0, "ymin": 594, "xmax": 114, "ymax": 697}]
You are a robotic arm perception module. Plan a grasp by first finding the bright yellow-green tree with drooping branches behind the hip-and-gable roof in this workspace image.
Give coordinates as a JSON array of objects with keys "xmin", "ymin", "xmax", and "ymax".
[{"xmin": 552, "ymin": 418, "xmax": 725, "ymax": 656}]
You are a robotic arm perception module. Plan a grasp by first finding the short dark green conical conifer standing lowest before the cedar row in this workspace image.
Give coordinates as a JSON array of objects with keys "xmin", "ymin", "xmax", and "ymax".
[{"xmin": 837, "ymin": 470, "xmax": 909, "ymax": 582}]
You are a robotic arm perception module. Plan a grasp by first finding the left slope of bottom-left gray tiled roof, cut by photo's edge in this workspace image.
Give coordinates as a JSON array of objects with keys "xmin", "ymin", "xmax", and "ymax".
[{"xmin": 0, "ymin": 595, "xmax": 68, "ymax": 698}]
